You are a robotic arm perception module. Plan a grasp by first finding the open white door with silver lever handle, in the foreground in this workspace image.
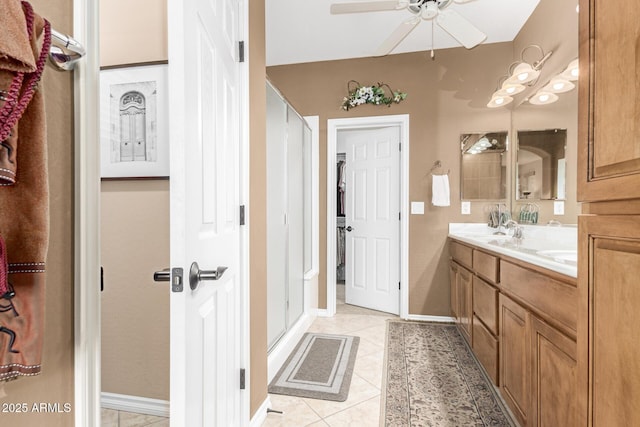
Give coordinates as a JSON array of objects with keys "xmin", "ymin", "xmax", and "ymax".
[{"xmin": 168, "ymin": 0, "xmax": 246, "ymax": 427}]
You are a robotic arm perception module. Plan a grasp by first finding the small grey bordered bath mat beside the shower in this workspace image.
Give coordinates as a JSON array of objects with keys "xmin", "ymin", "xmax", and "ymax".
[{"xmin": 269, "ymin": 333, "xmax": 360, "ymax": 402}]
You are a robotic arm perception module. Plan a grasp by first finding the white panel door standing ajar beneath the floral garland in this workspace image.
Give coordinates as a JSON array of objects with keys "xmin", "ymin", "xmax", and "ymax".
[{"xmin": 338, "ymin": 126, "xmax": 400, "ymax": 314}]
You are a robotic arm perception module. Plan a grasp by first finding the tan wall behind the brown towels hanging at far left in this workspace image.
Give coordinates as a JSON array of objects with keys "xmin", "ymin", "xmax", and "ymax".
[{"xmin": 0, "ymin": 0, "xmax": 75, "ymax": 427}]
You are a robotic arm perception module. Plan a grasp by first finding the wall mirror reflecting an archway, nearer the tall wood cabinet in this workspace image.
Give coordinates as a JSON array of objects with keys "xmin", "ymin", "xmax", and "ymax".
[{"xmin": 515, "ymin": 129, "xmax": 567, "ymax": 200}]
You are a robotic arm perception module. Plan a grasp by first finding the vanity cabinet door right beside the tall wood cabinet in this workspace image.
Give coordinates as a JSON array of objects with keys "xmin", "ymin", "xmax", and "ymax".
[{"xmin": 528, "ymin": 316, "xmax": 578, "ymax": 427}]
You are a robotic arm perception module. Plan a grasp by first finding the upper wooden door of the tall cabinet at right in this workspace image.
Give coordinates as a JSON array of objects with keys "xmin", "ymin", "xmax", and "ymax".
[{"xmin": 578, "ymin": 0, "xmax": 640, "ymax": 201}]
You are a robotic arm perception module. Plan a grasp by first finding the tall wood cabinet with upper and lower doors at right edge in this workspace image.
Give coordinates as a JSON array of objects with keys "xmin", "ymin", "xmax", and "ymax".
[{"xmin": 577, "ymin": 0, "xmax": 640, "ymax": 426}]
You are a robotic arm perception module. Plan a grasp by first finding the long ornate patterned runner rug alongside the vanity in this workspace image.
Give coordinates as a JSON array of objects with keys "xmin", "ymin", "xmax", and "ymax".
[{"xmin": 380, "ymin": 321, "xmax": 516, "ymax": 427}]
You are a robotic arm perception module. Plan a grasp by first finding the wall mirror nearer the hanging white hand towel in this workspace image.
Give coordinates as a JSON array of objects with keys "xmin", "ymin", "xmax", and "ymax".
[{"xmin": 460, "ymin": 131, "xmax": 508, "ymax": 200}]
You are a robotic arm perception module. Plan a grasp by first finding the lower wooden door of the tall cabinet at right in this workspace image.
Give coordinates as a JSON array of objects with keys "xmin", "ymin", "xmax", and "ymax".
[{"xmin": 578, "ymin": 215, "xmax": 640, "ymax": 427}]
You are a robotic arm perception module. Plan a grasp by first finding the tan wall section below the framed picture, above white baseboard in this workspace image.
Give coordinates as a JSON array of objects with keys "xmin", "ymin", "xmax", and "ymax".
[{"xmin": 100, "ymin": 180, "xmax": 169, "ymax": 400}]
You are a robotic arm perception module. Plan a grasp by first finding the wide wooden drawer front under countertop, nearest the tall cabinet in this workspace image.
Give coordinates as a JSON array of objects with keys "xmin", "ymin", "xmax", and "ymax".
[{"xmin": 500, "ymin": 261, "xmax": 578, "ymax": 337}]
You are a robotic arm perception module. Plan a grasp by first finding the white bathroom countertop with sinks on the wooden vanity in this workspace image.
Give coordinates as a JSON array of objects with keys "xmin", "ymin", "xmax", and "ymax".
[{"xmin": 449, "ymin": 223, "xmax": 578, "ymax": 278}]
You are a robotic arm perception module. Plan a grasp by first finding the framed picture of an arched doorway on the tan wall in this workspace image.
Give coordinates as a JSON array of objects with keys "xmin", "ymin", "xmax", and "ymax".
[{"xmin": 100, "ymin": 63, "xmax": 169, "ymax": 179}]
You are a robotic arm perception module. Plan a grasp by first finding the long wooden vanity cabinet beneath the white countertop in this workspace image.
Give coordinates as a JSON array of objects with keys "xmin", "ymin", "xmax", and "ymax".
[{"xmin": 451, "ymin": 239, "xmax": 580, "ymax": 427}]
